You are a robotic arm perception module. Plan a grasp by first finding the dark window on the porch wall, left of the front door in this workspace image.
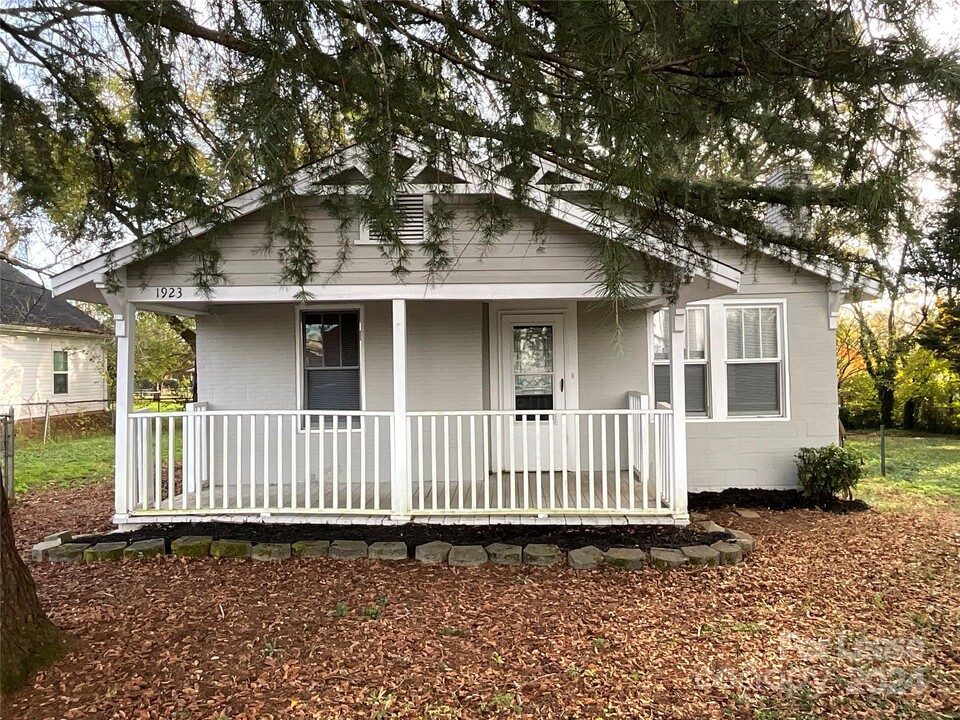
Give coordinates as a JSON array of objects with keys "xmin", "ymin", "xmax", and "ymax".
[{"xmin": 301, "ymin": 310, "xmax": 360, "ymax": 411}]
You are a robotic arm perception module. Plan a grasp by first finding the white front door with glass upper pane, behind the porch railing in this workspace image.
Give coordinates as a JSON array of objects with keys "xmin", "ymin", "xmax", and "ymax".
[{"xmin": 500, "ymin": 313, "xmax": 566, "ymax": 471}]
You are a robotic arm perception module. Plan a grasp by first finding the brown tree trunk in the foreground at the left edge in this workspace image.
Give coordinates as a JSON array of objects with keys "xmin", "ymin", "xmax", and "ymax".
[{"xmin": 0, "ymin": 480, "xmax": 65, "ymax": 694}]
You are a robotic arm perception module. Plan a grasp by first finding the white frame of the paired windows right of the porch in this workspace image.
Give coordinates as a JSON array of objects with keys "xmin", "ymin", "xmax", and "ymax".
[{"xmin": 647, "ymin": 297, "xmax": 792, "ymax": 423}]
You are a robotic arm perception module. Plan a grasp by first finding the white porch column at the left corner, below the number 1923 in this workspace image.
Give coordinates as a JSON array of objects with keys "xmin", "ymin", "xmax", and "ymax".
[{"xmin": 113, "ymin": 302, "xmax": 137, "ymax": 519}]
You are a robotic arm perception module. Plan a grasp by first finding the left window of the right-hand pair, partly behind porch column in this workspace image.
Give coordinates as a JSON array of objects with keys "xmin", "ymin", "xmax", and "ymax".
[{"xmin": 653, "ymin": 308, "xmax": 710, "ymax": 416}]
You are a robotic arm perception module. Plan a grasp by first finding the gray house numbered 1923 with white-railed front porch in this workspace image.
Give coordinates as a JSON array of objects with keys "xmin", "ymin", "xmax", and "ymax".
[{"xmin": 54, "ymin": 146, "xmax": 876, "ymax": 524}]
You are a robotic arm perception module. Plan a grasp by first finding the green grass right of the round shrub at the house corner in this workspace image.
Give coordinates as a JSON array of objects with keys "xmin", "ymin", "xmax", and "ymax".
[{"xmin": 847, "ymin": 430, "xmax": 960, "ymax": 510}]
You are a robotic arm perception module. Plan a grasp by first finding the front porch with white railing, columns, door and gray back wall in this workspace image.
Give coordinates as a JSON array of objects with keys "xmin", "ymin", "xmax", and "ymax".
[{"xmin": 114, "ymin": 292, "xmax": 687, "ymax": 525}]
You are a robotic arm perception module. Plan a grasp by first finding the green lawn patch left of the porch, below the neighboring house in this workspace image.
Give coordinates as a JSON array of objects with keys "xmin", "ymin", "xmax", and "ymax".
[{"xmin": 14, "ymin": 434, "xmax": 113, "ymax": 494}]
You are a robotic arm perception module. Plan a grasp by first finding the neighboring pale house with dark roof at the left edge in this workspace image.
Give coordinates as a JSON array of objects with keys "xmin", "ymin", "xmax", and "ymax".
[{"xmin": 0, "ymin": 261, "xmax": 109, "ymax": 419}]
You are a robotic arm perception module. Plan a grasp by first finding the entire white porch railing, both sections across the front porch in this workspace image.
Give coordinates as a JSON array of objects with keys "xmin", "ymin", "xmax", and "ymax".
[{"xmin": 126, "ymin": 394, "xmax": 677, "ymax": 517}]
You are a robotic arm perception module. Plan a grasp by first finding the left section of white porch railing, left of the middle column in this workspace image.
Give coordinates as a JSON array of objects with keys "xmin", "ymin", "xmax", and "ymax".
[{"xmin": 127, "ymin": 410, "xmax": 393, "ymax": 515}]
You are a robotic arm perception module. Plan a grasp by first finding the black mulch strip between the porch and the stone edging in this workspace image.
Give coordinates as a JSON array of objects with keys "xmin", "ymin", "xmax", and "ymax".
[{"xmin": 77, "ymin": 523, "xmax": 729, "ymax": 551}]
